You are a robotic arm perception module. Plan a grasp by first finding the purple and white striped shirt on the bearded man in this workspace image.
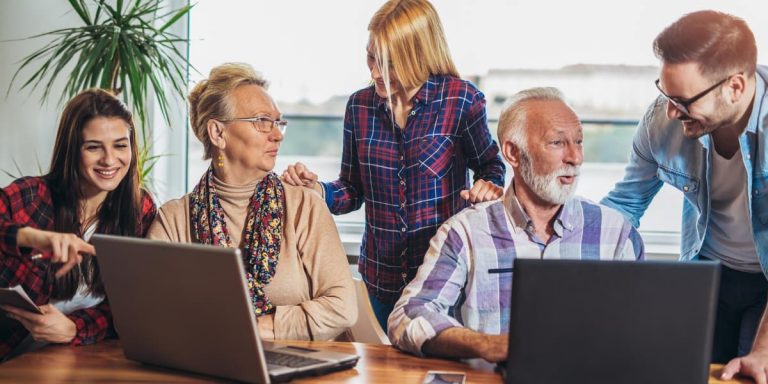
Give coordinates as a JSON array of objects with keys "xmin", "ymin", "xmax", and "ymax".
[{"xmin": 388, "ymin": 184, "xmax": 644, "ymax": 355}]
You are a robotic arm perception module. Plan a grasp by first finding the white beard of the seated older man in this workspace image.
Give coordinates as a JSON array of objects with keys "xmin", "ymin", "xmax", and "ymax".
[{"xmin": 520, "ymin": 152, "xmax": 581, "ymax": 205}]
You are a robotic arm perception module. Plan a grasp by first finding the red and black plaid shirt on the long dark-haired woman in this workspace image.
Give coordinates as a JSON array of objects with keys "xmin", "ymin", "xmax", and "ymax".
[{"xmin": 0, "ymin": 177, "xmax": 156, "ymax": 358}]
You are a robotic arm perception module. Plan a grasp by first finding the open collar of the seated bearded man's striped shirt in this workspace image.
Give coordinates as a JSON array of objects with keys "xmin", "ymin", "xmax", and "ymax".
[{"xmin": 504, "ymin": 179, "xmax": 580, "ymax": 237}]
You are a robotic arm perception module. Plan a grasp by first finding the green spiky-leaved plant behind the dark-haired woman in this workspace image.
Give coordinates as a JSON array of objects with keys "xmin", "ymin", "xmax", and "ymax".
[{"xmin": 9, "ymin": 0, "xmax": 192, "ymax": 188}]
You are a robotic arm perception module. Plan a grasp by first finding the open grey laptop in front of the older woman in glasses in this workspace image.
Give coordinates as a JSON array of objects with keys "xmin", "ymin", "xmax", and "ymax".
[{"xmin": 92, "ymin": 235, "xmax": 358, "ymax": 383}]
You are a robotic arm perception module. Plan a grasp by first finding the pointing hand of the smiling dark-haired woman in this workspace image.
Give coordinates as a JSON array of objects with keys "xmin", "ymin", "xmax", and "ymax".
[{"xmin": 16, "ymin": 227, "xmax": 96, "ymax": 277}]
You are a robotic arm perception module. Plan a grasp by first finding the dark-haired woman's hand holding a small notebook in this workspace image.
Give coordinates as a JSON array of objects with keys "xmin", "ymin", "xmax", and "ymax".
[{"xmin": 2, "ymin": 304, "xmax": 77, "ymax": 343}]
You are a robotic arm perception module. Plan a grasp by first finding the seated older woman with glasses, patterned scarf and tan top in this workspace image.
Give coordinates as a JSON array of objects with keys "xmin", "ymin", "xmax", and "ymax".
[{"xmin": 148, "ymin": 64, "xmax": 357, "ymax": 340}]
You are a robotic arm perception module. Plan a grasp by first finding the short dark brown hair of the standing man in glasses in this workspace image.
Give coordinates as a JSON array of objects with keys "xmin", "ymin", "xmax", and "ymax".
[{"xmin": 653, "ymin": 10, "xmax": 757, "ymax": 80}]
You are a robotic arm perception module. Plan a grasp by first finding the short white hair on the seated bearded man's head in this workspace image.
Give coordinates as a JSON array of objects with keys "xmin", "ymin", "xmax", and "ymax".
[{"xmin": 496, "ymin": 87, "xmax": 567, "ymax": 152}]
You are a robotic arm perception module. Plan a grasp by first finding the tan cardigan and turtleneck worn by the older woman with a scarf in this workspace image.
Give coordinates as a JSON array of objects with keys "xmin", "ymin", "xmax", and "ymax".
[{"xmin": 147, "ymin": 180, "xmax": 357, "ymax": 340}]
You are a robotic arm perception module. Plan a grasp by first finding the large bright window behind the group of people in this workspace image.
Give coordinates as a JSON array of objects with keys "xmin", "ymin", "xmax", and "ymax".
[{"xmin": 188, "ymin": 0, "xmax": 768, "ymax": 252}]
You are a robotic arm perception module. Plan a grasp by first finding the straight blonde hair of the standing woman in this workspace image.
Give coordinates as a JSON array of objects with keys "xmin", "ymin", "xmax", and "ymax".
[{"xmin": 368, "ymin": 0, "xmax": 459, "ymax": 94}]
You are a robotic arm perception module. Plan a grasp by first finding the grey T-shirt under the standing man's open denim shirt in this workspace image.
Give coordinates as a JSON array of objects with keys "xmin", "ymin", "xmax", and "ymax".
[{"xmin": 701, "ymin": 148, "xmax": 761, "ymax": 273}]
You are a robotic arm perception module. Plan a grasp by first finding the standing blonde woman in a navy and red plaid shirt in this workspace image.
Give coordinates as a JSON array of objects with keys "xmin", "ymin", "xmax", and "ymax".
[{"xmin": 283, "ymin": 0, "xmax": 504, "ymax": 328}]
